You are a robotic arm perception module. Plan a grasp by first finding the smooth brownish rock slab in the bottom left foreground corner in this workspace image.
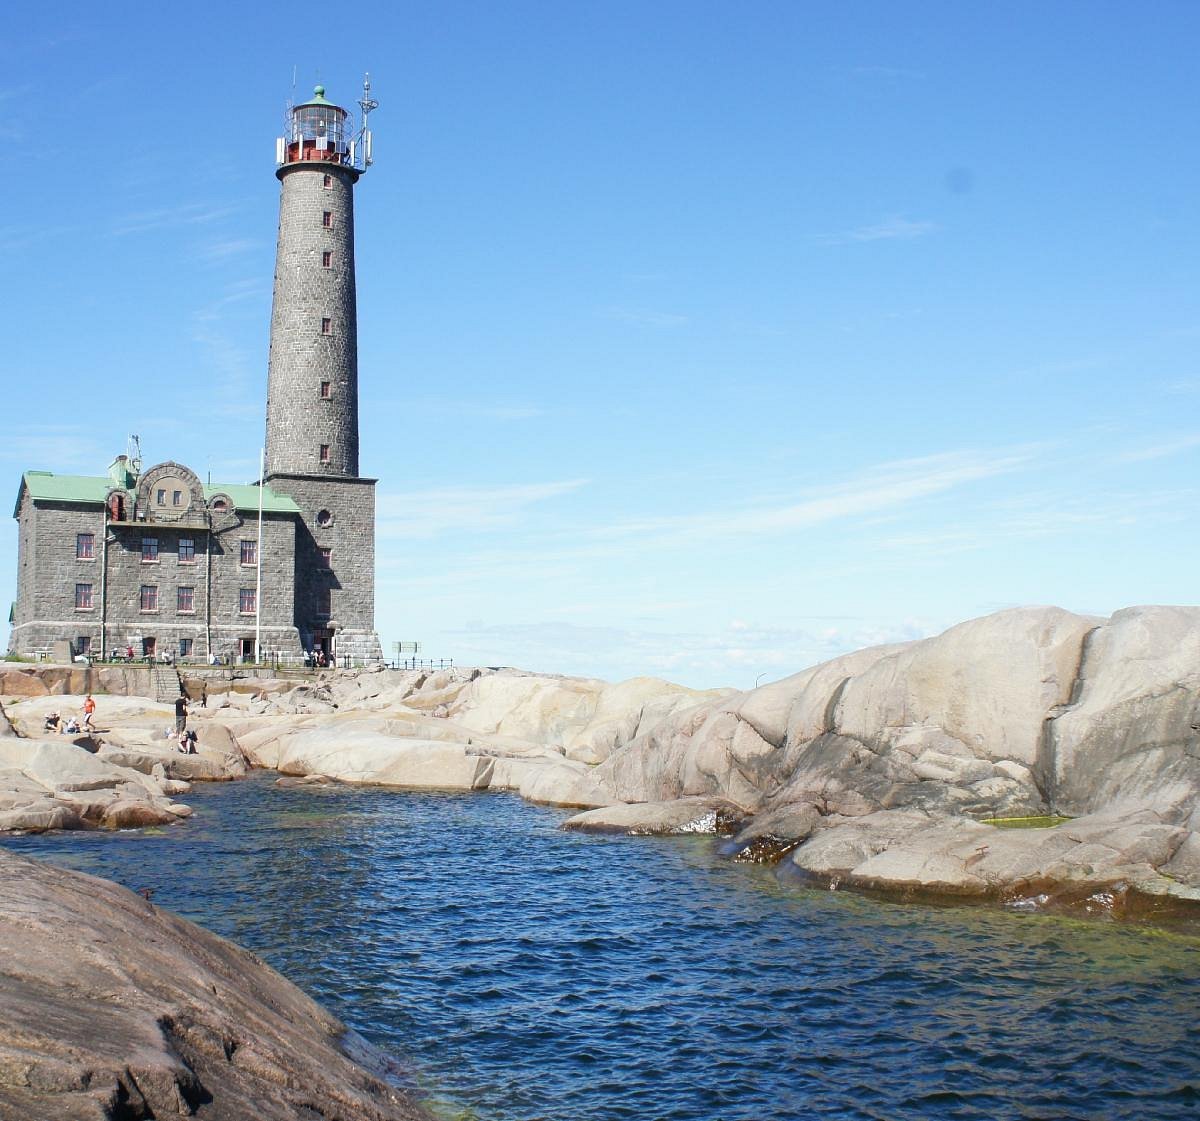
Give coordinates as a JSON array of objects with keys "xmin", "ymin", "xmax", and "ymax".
[{"xmin": 0, "ymin": 851, "xmax": 427, "ymax": 1121}]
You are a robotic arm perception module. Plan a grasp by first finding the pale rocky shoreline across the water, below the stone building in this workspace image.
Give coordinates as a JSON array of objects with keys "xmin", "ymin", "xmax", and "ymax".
[{"xmin": 0, "ymin": 607, "xmax": 1200, "ymax": 909}]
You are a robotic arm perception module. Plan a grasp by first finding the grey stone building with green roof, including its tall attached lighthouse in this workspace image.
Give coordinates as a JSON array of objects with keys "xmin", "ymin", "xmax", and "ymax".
[{"xmin": 8, "ymin": 86, "xmax": 382, "ymax": 663}]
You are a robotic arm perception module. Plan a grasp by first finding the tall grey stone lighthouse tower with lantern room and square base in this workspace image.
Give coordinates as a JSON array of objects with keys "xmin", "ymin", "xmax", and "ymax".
[{"xmin": 266, "ymin": 82, "xmax": 382, "ymax": 659}]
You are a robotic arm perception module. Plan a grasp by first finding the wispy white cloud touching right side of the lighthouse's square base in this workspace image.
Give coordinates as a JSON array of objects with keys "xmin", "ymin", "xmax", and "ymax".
[{"xmin": 377, "ymin": 479, "xmax": 588, "ymax": 539}]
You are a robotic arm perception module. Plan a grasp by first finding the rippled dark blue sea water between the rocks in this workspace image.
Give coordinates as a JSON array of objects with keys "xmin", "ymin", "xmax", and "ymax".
[{"xmin": 4, "ymin": 775, "xmax": 1200, "ymax": 1121}]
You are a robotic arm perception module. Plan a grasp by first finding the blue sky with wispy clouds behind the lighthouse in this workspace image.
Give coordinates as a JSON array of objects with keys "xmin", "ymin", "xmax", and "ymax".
[{"xmin": 0, "ymin": 0, "xmax": 1200, "ymax": 688}]
